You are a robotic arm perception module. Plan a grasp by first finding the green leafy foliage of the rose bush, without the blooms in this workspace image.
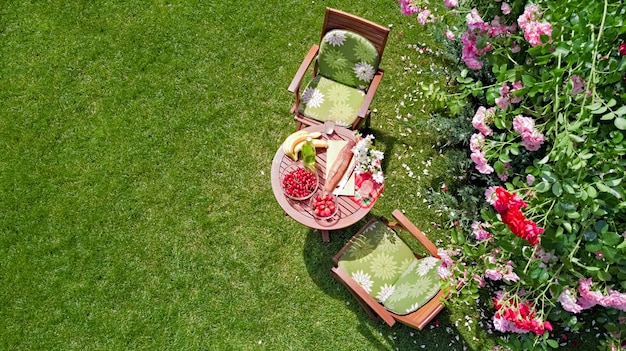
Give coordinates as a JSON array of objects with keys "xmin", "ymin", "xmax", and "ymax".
[{"xmin": 410, "ymin": 1, "xmax": 626, "ymax": 349}]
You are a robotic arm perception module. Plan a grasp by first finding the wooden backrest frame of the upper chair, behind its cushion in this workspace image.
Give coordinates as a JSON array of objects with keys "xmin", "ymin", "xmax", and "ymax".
[{"xmin": 320, "ymin": 7, "xmax": 389, "ymax": 60}]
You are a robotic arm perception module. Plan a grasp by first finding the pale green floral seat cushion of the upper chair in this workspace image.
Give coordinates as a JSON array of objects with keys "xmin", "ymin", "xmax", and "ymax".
[{"xmin": 298, "ymin": 75, "xmax": 365, "ymax": 126}]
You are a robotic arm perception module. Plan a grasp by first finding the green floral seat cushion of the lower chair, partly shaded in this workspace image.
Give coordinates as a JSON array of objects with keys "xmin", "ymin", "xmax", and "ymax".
[{"xmin": 338, "ymin": 221, "xmax": 417, "ymax": 302}]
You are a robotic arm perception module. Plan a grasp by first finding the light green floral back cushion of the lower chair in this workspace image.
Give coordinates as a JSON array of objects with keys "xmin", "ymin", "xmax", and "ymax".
[{"xmin": 383, "ymin": 257, "xmax": 441, "ymax": 315}]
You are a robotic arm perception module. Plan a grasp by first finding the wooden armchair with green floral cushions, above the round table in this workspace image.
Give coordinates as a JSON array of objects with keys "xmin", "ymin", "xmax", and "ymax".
[{"xmin": 288, "ymin": 8, "xmax": 389, "ymax": 129}]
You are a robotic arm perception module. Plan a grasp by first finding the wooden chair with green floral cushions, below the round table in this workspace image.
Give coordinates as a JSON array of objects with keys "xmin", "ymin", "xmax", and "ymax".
[{"xmin": 332, "ymin": 210, "xmax": 446, "ymax": 330}]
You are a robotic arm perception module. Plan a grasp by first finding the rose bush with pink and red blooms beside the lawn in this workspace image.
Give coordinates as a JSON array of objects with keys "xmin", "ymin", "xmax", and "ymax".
[{"xmin": 399, "ymin": 0, "xmax": 626, "ymax": 349}]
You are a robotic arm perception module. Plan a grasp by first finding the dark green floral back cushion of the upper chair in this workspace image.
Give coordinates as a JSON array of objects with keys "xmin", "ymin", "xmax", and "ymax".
[{"xmin": 317, "ymin": 29, "xmax": 379, "ymax": 90}]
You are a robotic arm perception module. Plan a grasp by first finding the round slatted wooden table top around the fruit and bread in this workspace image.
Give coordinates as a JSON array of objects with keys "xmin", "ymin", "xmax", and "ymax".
[{"xmin": 271, "ymin": 124, "xmax": 373, "ymax": 242}]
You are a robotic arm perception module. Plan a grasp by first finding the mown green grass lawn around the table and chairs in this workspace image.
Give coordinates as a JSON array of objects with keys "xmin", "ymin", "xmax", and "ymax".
[{"xmin": 0, "ymin": 0, "xmax": 596, "ymax": 350}]
